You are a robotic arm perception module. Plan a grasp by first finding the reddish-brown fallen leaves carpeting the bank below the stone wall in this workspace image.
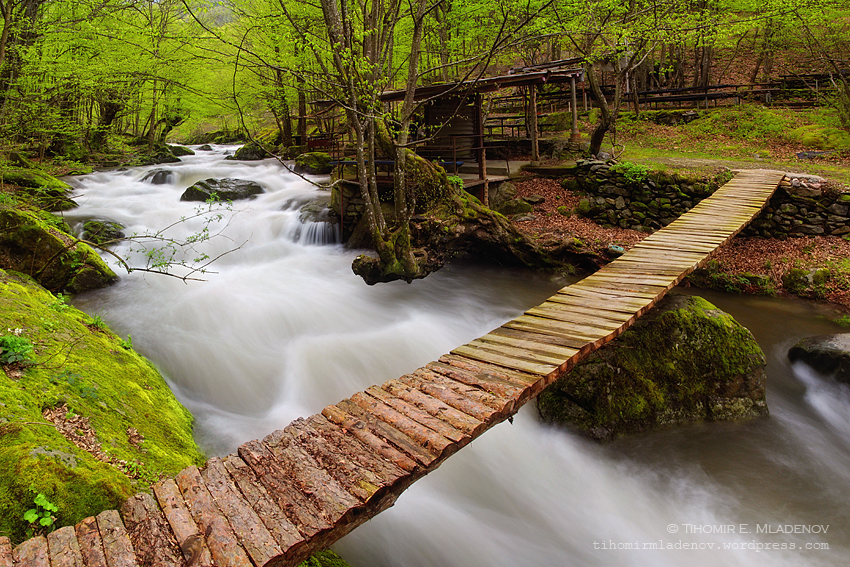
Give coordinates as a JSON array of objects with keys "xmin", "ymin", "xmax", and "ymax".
[{"xmin": 516, "ymin": 174, "xmax": 850, "ymax": 312}]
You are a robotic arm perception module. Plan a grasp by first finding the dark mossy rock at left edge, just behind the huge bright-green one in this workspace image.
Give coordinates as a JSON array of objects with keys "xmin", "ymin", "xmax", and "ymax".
[{"xmin": 0, "ymin": 208, "xmax": 118, "ymax": 293}]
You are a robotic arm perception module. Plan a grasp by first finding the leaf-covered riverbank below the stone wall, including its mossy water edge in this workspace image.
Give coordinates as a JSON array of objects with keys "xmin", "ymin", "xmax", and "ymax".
[{"xmin": 516, "ymin": 176, "xmax": 850, "ymax": 312}]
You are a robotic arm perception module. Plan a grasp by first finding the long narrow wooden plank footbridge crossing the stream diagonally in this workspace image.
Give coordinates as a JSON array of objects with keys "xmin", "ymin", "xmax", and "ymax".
[{"xmin": 0, "ymin": 171, "xmax": 782, "ymax": 567}]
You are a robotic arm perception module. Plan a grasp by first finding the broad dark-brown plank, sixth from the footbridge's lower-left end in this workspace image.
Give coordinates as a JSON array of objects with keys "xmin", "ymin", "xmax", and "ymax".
[{"xmin": 121, "ymin": 492, "xmax": 185, "ymax": 567}]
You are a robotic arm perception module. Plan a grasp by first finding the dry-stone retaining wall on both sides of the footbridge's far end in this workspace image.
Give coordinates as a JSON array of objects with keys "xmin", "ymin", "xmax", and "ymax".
[{"xmin": 564, "ymin": 160, "xmax": 850, "ymax": 238}]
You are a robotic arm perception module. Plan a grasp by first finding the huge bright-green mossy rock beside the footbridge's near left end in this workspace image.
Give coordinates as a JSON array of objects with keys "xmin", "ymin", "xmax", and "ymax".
[{"xmin": 0, "ymin": 270, "xmax": 203, "ymax": 542}]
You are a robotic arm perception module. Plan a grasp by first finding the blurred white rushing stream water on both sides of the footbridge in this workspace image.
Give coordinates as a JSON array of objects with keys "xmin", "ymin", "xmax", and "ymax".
[{"xmin": 68, "ymin": 148, "xmax": 850, "ymax": 567}]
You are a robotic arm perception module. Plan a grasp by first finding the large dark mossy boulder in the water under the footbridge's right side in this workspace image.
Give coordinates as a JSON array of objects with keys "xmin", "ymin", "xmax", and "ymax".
[{"xmin": 537, "ymin": 295, "xmax": 768, "ymax": 439}]
